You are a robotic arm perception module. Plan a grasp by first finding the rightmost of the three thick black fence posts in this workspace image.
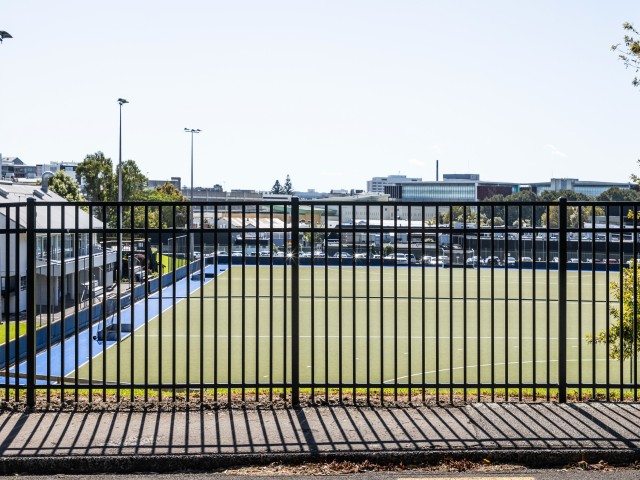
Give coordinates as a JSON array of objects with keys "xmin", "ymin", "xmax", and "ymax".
[{"xmin": 558, "ymin": 197, "xmax": 567, "ymax": 403}]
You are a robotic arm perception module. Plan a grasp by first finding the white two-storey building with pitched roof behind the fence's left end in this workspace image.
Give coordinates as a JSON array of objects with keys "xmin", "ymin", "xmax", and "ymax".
[{"xmin": 0, "ymin": 182, "xmax": 117, "ymax": 317}]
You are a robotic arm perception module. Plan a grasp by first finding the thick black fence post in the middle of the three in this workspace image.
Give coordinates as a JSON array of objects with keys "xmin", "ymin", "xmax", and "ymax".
[{"xmin": 291, "ymin": 197, "xmax": 300, "ymax": 406}]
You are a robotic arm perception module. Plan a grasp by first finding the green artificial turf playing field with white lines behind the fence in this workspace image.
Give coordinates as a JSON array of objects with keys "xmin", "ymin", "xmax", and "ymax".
[{"xmin": 74, "ymin": 265, "xmax": 630, "ymax": 387}]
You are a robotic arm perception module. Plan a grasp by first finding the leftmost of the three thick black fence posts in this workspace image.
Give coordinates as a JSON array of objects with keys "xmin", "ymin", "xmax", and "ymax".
[{"xmin": 26, "ymin": 198, "xmax": 36, "ymax": 407}]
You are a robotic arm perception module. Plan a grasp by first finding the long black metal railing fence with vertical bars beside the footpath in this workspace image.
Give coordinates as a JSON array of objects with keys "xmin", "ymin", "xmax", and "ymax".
[{"xmin": 0, "ymin": 198, "xmax": 640, "ymax": 405}]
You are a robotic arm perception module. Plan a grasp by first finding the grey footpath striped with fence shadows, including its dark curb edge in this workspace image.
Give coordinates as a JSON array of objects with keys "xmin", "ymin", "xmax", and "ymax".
[{"xmin": 0, "ymin": 402, "xmax": 640, "ymax": 475}]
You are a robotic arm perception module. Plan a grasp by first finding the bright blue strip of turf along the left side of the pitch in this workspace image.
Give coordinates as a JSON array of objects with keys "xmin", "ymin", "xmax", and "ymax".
[{"xmin": 10, "ymin": 264, "xmax": 228, "ymax": 385}]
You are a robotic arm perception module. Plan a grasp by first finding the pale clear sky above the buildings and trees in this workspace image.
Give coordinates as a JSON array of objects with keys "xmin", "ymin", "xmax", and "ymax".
[{"xmin": 0, "ymin": 0, "xmax": 640, "ymax": 191}]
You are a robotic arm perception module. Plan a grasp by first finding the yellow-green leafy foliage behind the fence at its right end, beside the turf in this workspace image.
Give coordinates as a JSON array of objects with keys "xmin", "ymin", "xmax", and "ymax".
[{"xmin": 587, "ymin": 261, "xmax": 640, "ymax": 360}]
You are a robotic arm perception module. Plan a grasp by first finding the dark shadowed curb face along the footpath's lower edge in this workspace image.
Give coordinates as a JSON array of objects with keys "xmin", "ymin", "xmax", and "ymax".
[{"xmin": 0, "ymin": 449, "xmax": 640, "ymax": 475}]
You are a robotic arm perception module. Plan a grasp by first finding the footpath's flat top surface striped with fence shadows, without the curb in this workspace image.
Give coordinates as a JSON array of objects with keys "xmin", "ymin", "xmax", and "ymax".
[{"xmin": 0, "ymin": 403, "xmax": 640, "ymax": 458}]
